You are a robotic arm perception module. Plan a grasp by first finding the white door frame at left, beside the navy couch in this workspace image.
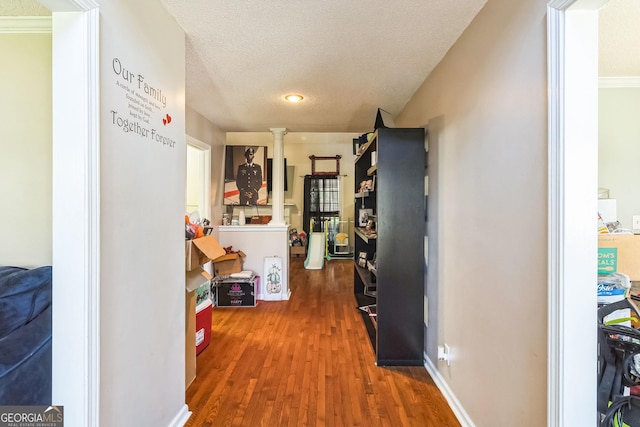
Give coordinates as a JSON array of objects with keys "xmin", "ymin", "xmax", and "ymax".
[{"xmin": 40, "ymin": 0, "xmax": 100, "ymax": 427}]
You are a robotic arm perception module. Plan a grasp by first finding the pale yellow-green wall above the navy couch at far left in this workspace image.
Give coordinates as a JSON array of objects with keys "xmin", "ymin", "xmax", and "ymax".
[{"xmin": 0, "ymin": 34, "xmax": 52, "ymax": 267}]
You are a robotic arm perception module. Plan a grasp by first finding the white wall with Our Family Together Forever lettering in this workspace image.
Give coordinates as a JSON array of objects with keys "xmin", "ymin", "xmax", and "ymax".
[{"xmin": 97, "ymin": 0, "xmax": 186, "ymax": 426}]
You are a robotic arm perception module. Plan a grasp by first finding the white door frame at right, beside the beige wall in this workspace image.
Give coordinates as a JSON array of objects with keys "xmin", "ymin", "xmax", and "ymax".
[{"xmin": 547, "ymin": 0, "xmax": 606, "ymax": 426}]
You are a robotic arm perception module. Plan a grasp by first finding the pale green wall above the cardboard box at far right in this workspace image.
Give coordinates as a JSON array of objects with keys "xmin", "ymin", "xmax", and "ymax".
[{"xmin": 598, "ymin": 87, "xmax": 640, "ymax": 229}]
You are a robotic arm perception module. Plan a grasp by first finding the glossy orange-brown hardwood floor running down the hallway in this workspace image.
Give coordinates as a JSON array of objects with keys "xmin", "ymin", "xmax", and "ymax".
[{"xmin": 186, "ymin": 258, "xmax": 460, "ymax": 427}]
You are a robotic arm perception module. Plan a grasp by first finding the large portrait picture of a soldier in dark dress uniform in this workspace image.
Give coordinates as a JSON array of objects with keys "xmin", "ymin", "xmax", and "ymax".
[{"xmin": 224, "ymin": 145, "xmax": 268, "ymax": 206}]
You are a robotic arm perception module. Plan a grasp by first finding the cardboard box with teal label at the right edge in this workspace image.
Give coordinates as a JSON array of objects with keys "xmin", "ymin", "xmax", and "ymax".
[{"xmin": 598, "ymin": 234, "xmax": 640, "ymax": 281}]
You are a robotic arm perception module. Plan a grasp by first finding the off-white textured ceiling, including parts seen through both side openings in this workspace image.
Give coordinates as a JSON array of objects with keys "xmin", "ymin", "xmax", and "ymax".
[{"xmin": 5, "ymin": 0, "xmax": 640, "ymax": 133}]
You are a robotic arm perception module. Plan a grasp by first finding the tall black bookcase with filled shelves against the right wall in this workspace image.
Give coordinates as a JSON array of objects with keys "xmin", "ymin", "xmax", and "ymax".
[{"xmin": 354, "ymin": 128, "xmax": 425, "ymax": 366}]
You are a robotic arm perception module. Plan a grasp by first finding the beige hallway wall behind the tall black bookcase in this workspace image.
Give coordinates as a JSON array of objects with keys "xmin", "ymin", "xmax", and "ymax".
[{"xmin": 395, "ymin": 0, "xmax": 547, "ymax": 426}]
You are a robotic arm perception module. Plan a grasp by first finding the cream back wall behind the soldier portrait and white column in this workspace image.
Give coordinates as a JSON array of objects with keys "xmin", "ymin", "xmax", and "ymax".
[{"xmin": 225, "ymin": 132, "xmax": 359, "ymax": 236}]
